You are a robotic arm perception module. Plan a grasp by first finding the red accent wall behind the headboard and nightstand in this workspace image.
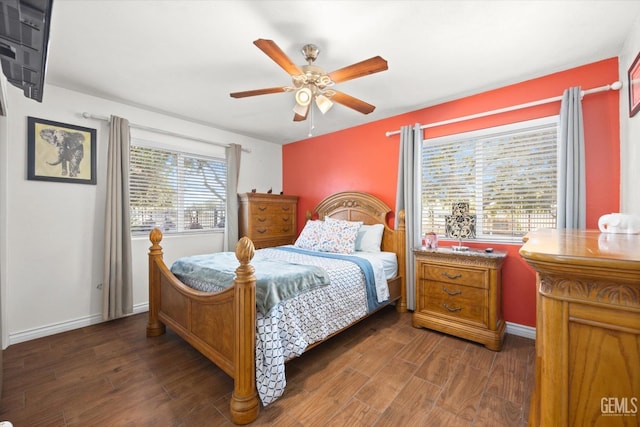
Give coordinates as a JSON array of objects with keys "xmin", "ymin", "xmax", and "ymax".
[{"xmin": 282, "ymin": 58, "xmax": 620, "ymax": 326}]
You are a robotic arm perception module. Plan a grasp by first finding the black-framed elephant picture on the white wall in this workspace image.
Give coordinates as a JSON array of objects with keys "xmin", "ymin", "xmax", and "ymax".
[{"xmin": 27, "ymin": 117, "xmax": 96, "ymax": 185}]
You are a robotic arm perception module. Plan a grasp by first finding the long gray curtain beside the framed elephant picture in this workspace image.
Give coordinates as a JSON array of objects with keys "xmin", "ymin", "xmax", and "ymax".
[{"xmin": 102, "ymin": 116, "xmax": 133, "ymax": 320}]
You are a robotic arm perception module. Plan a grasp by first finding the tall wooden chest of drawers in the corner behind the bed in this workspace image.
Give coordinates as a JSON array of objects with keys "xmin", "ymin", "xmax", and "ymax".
[{"xmin": 238, "ymin": 193, "xmax": 298, "ymax": 249}]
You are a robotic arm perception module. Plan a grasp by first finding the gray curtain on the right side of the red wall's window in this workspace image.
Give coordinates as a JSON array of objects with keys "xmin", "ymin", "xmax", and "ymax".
[{"xmin": 557, "ymin": 87, "xmax": 587, "ymax": 229}]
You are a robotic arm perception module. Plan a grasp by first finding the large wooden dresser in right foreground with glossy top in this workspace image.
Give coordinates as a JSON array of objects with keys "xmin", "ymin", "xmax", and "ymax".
[{"xmin": 520, "ymin": 230, "xmax": 640, "ymax": 426}]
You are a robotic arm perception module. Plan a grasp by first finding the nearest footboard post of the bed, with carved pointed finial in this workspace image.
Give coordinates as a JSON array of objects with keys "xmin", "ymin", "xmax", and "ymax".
[{"xmin": 229, "ymin": 236, "xmax": 260, "ymax": 424}]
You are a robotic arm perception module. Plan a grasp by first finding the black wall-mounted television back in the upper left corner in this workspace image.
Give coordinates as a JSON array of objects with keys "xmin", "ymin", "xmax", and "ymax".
[{"xmin": 0, "ymin": 0, "xmax": 53, "ymax": 102}]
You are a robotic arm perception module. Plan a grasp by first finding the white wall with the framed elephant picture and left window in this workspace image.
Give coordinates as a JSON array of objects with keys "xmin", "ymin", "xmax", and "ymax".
[{"xmin": 0, "ymin": 85, "xmax": 282, "ymax": 348}]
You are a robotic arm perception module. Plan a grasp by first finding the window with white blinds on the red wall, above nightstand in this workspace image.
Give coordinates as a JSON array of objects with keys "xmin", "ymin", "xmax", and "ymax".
[{"xmin": 421, "ymin": 116, "xmax": 558, "ymax": 242}]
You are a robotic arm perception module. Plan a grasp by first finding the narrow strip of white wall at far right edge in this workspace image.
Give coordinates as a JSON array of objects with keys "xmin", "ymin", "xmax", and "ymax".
[{"xmin": 619, "ymin": 11, "xmax": 640, "ymax": 215}]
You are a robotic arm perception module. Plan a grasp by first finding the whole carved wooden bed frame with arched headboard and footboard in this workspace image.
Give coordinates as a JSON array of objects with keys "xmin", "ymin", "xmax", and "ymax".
[{"xmin": 147, "ymin": 192, "xmax": 407, "ymax": 424}]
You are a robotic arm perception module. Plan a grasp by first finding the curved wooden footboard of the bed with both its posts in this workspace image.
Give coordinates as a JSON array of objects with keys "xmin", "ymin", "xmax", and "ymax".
[{"xmin": 147, "ymin": 229, "xmax": 260, "ymax": 424}]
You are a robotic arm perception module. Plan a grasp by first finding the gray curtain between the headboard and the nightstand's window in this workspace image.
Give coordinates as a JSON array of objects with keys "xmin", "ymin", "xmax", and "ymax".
[{"xmin": 395, "ymin": 124, "xmax": 422, "ymax": 310}]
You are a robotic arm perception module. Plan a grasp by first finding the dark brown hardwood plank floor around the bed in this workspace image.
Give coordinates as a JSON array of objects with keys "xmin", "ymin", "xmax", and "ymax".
[{"xmin": 0, "ymin": 308, "xmax": 534, "ymax": 427}]
